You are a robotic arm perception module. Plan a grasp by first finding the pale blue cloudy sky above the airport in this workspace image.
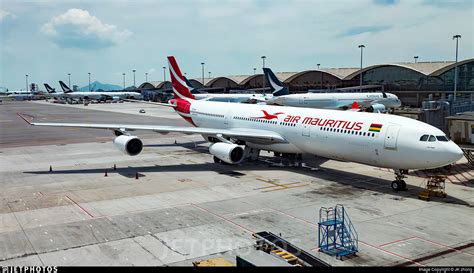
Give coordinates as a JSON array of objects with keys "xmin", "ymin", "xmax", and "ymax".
[{"xmin": 0, "ymin": 0, "xmax": 474, "ymax": 90}]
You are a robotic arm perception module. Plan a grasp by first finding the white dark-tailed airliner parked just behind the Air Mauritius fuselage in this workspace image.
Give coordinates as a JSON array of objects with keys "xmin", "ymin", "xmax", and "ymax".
[{"xmin": 263, "ymin": 68, "xmax": 401, "ymax": 112}]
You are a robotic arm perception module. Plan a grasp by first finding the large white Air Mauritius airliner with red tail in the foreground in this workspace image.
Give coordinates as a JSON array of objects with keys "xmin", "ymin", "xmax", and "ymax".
[{"xmin": 18, "ymin": 57, "xmax": 463, "ymax": 190}]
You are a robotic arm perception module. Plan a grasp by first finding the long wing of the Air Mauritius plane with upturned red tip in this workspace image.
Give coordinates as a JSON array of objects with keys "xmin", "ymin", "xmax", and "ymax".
[{"xmin": 18, "ymin": 113, "xmax": 288, "ymax": 144}]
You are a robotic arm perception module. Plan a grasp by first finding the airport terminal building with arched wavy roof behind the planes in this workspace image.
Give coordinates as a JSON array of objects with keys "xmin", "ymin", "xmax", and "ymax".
[{"xmin": 138, "ymin": 58, "xmax": 474, "ymax": 107}]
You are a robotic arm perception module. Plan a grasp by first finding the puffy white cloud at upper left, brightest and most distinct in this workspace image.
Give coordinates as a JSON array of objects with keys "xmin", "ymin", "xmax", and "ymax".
[{"xmin": 41, "ymin": 9, "xmax": 132, "ymax": 49}]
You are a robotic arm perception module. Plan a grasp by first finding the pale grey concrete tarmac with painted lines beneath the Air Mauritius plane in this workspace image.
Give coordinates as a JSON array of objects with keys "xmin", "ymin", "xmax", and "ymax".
[{"xmin": 0, "ymin": 101, "xmax": 474, "ymax": 266}]
